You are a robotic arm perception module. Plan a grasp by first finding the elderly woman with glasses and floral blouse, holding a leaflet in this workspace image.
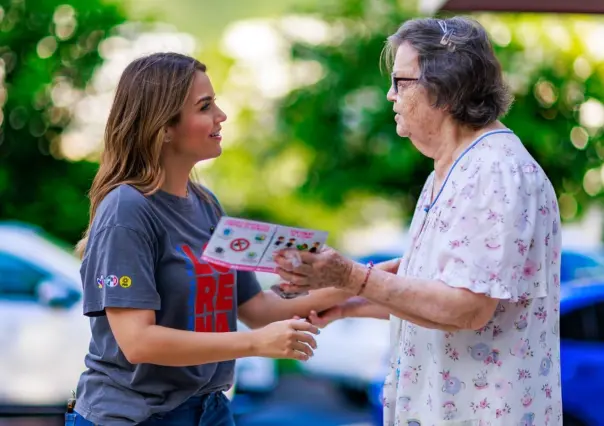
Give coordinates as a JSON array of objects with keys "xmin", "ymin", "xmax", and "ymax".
[{"xmin": 276, "ymin": 18, "xmax": 562, "ymax": 426}]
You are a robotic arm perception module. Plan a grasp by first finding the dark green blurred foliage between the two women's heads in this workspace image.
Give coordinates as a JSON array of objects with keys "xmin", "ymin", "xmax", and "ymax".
[{"xmin": 276, "ymin": 0, "xmax": 432, "ymax": 220}]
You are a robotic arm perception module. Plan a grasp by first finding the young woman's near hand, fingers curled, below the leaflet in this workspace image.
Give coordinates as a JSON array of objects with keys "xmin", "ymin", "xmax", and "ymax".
[{"xmin": 251, "ymin": 319, "xmax": 319, "ymax": 361}]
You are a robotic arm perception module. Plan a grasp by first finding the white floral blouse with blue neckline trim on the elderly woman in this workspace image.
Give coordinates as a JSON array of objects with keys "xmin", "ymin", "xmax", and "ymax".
[{"xmin": 384, "ymin": 130, "xmax": 562, "ymax": 426}]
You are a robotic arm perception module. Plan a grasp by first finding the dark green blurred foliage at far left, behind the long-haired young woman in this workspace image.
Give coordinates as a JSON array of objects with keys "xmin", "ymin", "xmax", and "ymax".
[{"xmin": 0, "ymin": 0, "xmax": 124, "ymax": 242}]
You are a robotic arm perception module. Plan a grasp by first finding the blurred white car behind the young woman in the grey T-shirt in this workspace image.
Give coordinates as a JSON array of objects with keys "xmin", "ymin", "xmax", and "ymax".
[{"xmin": 0, "ymin": 223, "xmax": 277, "ymax": 412}]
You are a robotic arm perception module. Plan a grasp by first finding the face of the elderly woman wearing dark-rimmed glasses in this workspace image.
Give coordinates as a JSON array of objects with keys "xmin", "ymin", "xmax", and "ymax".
[{"xmin": 387, "ymin": 42, "xmax": 444, "ymax": 156}]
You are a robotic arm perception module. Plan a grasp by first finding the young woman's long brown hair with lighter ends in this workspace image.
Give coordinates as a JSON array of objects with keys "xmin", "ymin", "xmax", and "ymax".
[{"xmin": 76, "ymin": 53, "xmax": 212, "ymax": 257}]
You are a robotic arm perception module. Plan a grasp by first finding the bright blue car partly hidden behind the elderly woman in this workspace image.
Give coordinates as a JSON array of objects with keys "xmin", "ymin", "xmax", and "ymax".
[{"xmin": 369, "ymin": 278, "xmax": 604, "ymax": 426}]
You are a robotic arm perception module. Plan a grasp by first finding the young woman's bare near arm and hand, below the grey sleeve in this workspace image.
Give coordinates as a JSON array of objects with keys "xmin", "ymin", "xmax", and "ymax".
[{"xmin": 106, "ymin": 308, "xmax": 319, "ymax": 367}]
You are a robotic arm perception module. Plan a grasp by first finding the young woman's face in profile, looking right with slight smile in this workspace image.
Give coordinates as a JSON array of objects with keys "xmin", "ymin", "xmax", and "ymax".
[{"xmin": 164, "ymin": 71, "xmax": 227, "ymax": 162}]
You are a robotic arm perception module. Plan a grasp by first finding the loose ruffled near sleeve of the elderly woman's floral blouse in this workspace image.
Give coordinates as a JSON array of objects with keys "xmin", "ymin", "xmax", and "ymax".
[{"xmin": 436, "ymin": 162, "xmax": 557, "ymax": 301}]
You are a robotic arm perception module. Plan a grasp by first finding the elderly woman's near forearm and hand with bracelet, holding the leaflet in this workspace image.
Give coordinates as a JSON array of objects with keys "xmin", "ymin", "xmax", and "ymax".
[{"xmin": 275, "ymin": 249, "xmax": 498, "ymax": 331}]
